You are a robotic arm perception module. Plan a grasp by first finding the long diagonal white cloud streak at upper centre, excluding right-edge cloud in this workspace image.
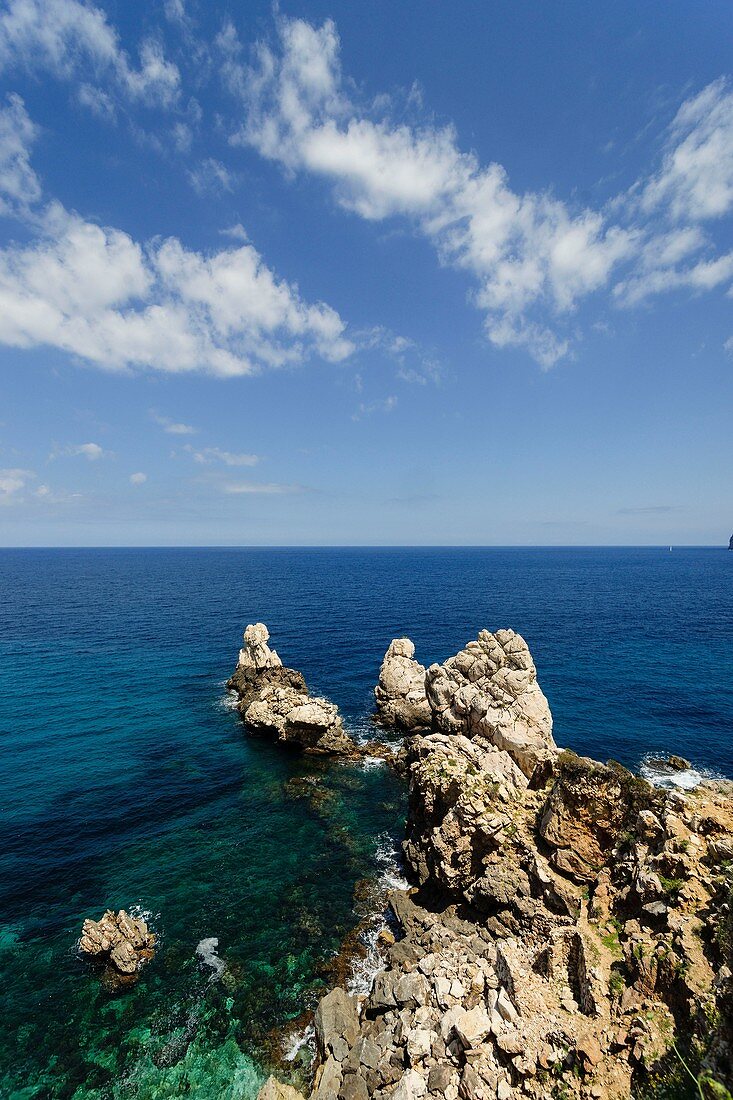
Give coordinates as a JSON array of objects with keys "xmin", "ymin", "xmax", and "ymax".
[{"xmin": 231, "ymin": 19, "xmax": 635, "ymax": 365}]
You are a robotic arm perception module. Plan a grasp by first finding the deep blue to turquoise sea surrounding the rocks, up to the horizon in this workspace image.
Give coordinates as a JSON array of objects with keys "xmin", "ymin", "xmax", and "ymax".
[{"xmin": 0, "ymin": 549, "xmax": 733, "ymax": 1100}]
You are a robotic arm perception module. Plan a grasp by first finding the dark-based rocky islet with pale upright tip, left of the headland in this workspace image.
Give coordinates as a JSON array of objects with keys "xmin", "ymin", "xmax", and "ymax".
[{"xmin": 227, "ymin": 623, "xmax": 359, "ymax": 756}]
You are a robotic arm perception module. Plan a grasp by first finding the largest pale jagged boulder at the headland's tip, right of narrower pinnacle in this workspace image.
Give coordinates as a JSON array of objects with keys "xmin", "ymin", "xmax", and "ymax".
[{"xmin": 425, "ymin": 630, "xmax": 557, "ymax": 782}]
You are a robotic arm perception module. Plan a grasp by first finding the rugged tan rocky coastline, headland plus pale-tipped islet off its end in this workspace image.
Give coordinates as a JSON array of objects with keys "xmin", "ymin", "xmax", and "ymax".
[{"xmin": 253, "ymin": 624, "xmax": 733, "ymax": 1100}]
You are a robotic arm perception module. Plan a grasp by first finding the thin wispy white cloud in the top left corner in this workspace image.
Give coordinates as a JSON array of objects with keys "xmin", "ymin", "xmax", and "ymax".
[{"xmin": 0, "ymin": 0, "xmax": 180, "ymax": 107}]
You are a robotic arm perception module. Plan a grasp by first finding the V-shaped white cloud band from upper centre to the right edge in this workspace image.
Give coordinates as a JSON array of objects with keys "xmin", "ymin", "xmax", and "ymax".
[{"xmin": 228, "ymin": 17, "xmax": 733, "ymax": 367}]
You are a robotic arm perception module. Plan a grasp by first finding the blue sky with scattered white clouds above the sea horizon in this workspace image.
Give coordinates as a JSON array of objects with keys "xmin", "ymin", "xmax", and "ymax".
[{"xmin": 0, "ymin": 0, "xmax": 733, "ymax": 546}]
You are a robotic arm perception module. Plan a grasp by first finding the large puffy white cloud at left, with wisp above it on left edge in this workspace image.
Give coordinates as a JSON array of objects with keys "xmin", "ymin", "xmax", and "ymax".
[{"xmin": 0, "ymin": 100, "xmax": 353, "ymax": 376}]
